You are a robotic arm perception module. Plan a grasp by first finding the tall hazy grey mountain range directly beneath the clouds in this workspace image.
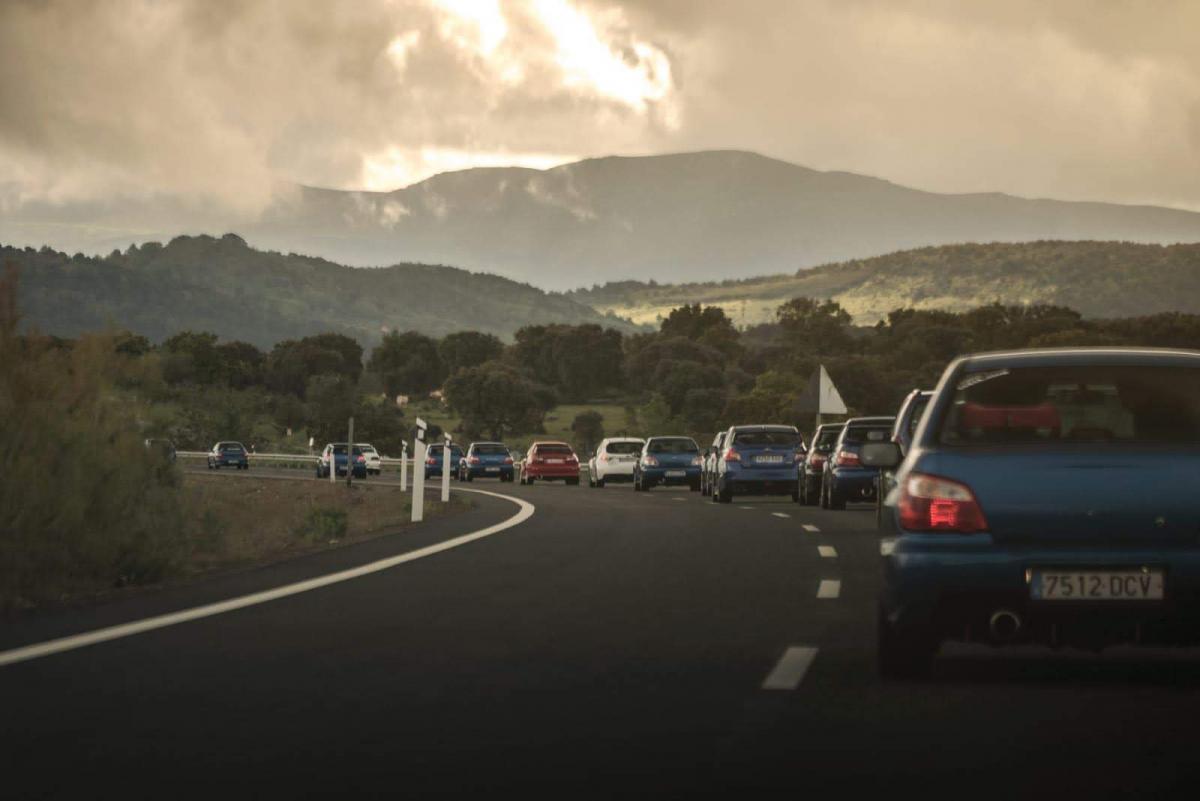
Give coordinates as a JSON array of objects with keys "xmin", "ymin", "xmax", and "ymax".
[{"xmin": 0, "ymin": 151, "xmax": 1200, "ymax": 289}]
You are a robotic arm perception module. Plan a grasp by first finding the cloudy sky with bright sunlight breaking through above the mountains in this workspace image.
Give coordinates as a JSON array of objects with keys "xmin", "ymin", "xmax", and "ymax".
[{"xmin": 0, "ymin": 0, "xmax": 1200, "ymax": 211}]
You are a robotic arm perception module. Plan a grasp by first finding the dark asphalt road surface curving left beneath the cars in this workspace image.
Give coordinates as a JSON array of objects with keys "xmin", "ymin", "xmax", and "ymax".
[{"xmin": 0, "ymin": 474, "xmax": 1200, "ymax": 801}]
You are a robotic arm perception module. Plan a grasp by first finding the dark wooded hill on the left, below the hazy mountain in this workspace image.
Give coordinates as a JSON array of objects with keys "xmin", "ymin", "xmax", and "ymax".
[{"xmin": 0, "ymin": 234, "xmax": 632, "ymax": 347}]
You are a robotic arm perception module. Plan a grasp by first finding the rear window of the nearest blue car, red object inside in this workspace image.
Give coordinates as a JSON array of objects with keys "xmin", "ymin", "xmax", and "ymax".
[{"xmin": 940, "ymin": 366, "xmax": 1200, "ymax": 446}]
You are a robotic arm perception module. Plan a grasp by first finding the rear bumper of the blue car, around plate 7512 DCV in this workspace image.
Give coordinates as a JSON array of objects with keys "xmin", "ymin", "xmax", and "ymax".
[{"xmin": 881, "ymin": 534, "xmax": 1200, "ymax": 645}]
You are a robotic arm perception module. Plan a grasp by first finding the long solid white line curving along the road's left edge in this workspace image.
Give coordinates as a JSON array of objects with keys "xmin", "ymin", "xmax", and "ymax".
[{"xmin": 0, "ymin": 487, "xmax": 535, "ymax": 667}]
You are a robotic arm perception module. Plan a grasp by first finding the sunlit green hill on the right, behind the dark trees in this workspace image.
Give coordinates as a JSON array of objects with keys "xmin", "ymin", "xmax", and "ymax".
[{"xmin": 568, "ymin": 241, "xmax": 1200, "ymax": 325}]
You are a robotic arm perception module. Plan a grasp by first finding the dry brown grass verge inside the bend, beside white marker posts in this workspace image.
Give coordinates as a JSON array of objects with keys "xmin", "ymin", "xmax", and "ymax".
[{"xmin": 182, "ymin": 474, "xmax": 472, "ymax": 573}]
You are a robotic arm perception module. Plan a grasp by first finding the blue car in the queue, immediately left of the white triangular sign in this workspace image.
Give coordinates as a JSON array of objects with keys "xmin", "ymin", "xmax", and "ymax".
[{"xmin": 712, "ymin": 426, "xmax": 805, "ymax": 504}]
